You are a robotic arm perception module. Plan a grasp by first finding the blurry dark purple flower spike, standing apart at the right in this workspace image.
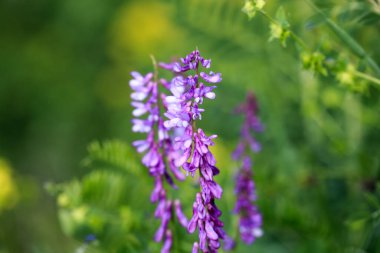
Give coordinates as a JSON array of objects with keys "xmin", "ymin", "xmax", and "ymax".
[{"xmin": 232, "ymin": 93, "xmax": 263, "ymax": 244}]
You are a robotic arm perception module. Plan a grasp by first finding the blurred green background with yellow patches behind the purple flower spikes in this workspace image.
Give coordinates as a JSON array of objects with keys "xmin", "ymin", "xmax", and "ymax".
[{"xmin": 0, "ymin": 0, "xmax": 380, "ymax": 253}]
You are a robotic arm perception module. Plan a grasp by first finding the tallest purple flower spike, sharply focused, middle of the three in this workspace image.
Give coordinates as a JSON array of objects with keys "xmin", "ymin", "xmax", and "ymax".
[{"xmin": 160, "ymin": 50, "xmax": 225, "ymax": 253}]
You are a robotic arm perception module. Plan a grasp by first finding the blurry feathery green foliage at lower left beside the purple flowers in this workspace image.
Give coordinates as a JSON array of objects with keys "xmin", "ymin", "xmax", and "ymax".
[{"xmin": 47, "ymin": 140, "xmax": 151, "ymax": 252}]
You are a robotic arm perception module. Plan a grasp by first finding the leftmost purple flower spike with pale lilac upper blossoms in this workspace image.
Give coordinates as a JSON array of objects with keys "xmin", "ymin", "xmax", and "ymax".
[{"xmin": 129, "ymin": 72, "xmax": 188, "ymax": 253}]
